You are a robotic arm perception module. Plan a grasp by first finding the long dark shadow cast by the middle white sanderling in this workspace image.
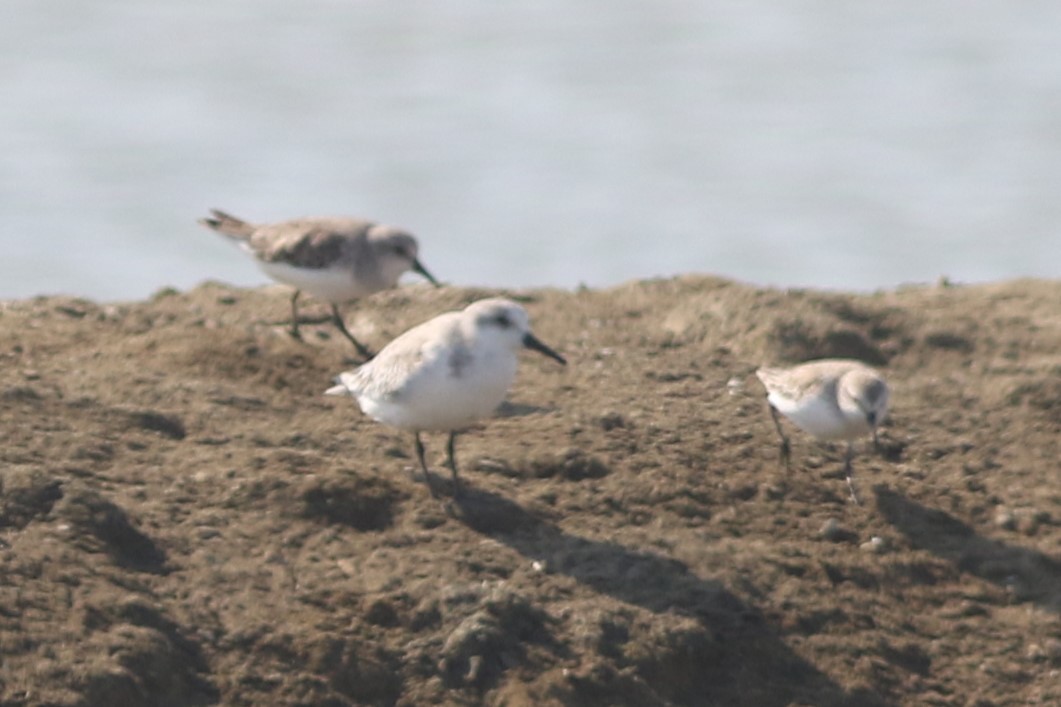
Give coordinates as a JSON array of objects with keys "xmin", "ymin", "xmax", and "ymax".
[{"xmin": 451, "ymin": 486, "xmax": 887, "ymax": 706}]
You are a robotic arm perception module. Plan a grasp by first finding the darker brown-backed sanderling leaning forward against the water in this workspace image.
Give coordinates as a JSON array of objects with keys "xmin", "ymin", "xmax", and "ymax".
[{"xmin": 199, "ymin": 209, "xmax": 438, "ymax": 358}]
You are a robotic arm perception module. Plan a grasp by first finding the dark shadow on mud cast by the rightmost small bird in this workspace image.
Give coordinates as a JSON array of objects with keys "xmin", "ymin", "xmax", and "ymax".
[{"xmin": 873, "ymin": 486, "xmax": 1061, "ymax": 613}]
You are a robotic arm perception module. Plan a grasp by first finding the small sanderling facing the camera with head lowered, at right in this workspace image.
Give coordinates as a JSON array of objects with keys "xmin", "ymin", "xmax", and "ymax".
[{"xmin": 755, "ymin": 359, "xmax": 888, "ymax": 503}]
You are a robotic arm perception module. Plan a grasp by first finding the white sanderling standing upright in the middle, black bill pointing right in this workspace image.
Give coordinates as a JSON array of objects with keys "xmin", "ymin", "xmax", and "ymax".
[{"xmin": 326, "ymin": 298, "xmax": 567, "ymax": 496}]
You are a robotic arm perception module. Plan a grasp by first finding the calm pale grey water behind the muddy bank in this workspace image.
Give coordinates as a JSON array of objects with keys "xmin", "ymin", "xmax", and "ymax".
[{"xmin": 0, "ymin": 0, "xmax": 1061, "ymax": 299}]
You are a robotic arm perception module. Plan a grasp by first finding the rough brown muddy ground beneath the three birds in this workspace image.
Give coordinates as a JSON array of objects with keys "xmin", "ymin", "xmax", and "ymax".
[{"xmin": 0, "ymin": 276, "xmax": 1061, "ymax": 707}]
